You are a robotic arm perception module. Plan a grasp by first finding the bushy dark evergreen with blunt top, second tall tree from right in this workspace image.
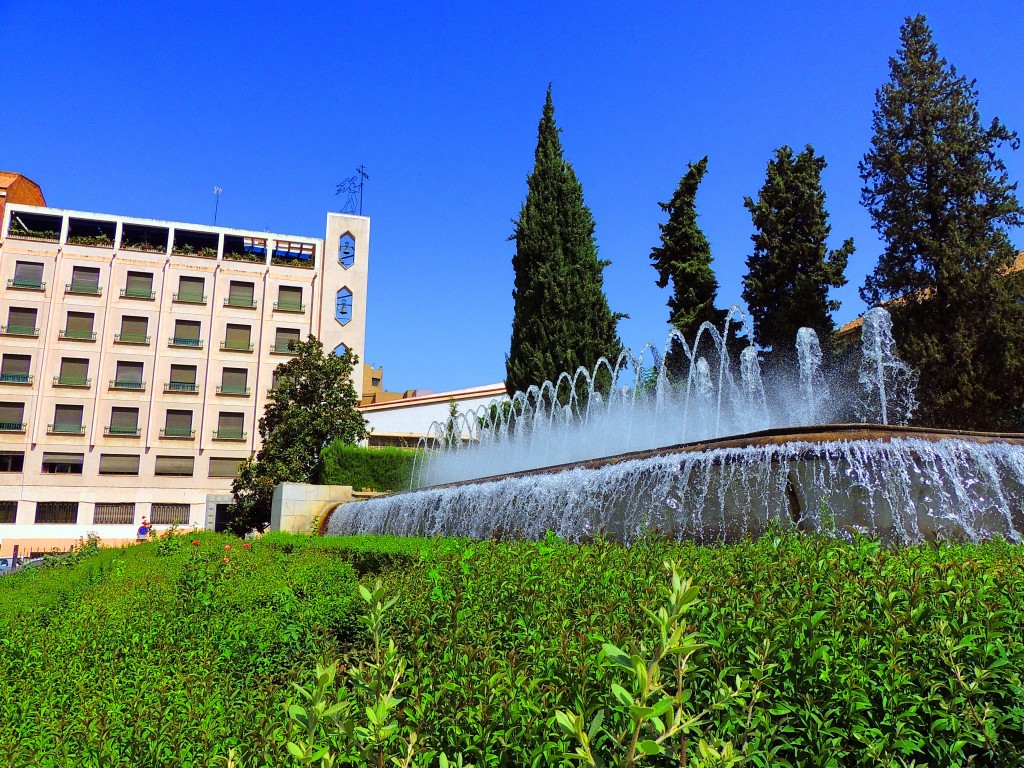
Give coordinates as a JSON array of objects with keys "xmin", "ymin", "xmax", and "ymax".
[{"xmin": 742, "ymin": 144, "xmax": 853, "ymax": 358}]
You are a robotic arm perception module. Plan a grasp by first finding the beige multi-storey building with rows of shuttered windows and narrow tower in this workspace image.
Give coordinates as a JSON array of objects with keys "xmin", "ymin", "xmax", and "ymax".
[{"xmin": 0, "ymin": 203, "xmax": 370, "ymax": 555}]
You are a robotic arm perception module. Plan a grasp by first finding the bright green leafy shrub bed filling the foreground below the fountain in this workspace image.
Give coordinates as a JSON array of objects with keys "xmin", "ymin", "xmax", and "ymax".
[{"xmin": 0, "ymin": 534, "xmax": 1024, "ymax": 768}]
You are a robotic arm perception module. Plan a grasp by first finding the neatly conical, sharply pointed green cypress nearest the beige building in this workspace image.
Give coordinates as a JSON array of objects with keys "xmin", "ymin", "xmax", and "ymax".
[{"xmin": 505, "ymin": 86, "xmax": 624, "ymax": 394}]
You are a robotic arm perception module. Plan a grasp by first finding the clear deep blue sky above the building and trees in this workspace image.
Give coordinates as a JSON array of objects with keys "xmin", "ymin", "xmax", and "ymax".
[{"xmin": 0, "ymin": 0, "xmax": 1024, "ymax": 390}]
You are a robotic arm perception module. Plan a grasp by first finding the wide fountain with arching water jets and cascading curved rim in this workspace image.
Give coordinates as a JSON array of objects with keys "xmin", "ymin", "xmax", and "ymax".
[{"xmin": 324, "ymin": 307, "xmax": 1024, "ymax": 543}]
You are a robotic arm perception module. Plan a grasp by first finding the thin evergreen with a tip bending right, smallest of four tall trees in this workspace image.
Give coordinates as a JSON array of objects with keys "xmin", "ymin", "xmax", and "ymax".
[{"xmin": 650, "ymin": 157, "xmax": 725, "ymax": 342}]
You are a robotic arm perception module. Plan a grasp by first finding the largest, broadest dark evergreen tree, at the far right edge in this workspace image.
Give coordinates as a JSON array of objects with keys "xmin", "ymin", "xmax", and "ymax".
[{"xmin": 860, "ymin": 15, "xmax": 1024, "ymax": 429}]
